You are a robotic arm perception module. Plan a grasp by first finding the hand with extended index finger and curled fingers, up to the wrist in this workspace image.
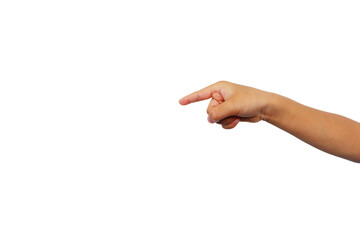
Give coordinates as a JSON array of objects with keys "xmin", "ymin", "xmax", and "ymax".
[{"xmin": 179, "ymin": 81, "xmax": 271, "ymax": 129}]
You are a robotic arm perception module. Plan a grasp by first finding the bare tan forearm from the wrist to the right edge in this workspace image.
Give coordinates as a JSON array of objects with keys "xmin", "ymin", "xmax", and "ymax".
[{"xmin": 264, "ymin": 94, "xmax": 360, "ymax": 162}]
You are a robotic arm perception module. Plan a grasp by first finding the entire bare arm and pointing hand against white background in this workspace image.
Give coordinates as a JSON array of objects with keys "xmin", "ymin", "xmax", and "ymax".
[{"xmin": 179, "ymin": 81, "xmax": 360, "ymax": 163}]
